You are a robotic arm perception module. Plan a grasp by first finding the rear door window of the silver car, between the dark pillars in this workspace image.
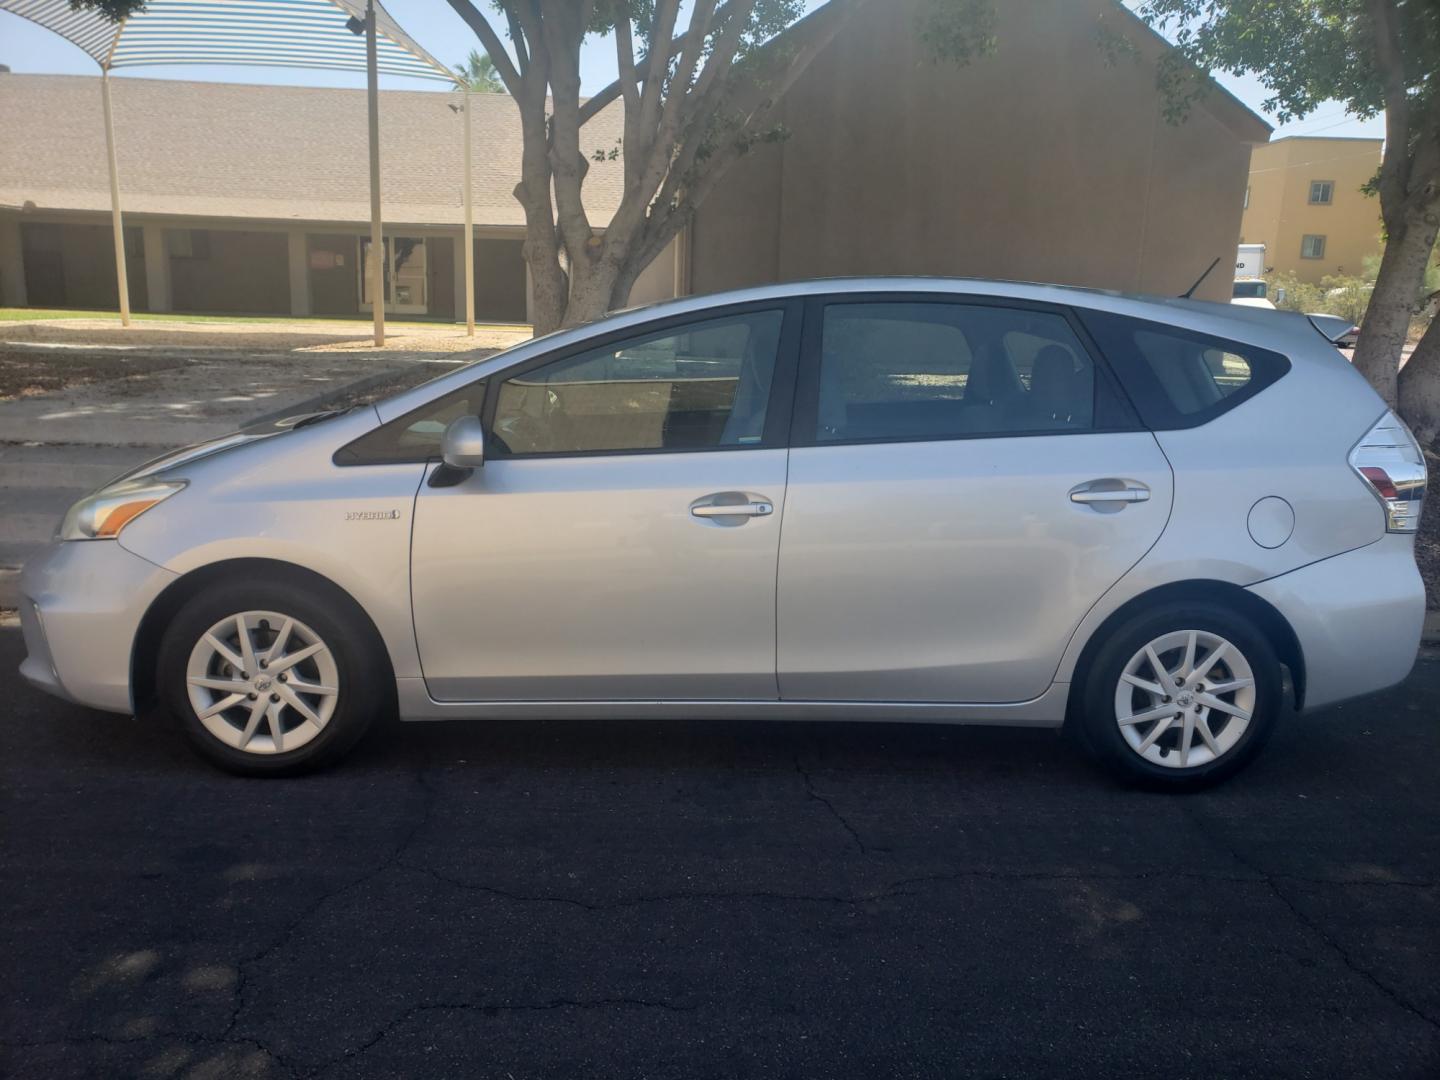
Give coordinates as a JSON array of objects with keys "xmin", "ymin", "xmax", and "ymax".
[{"xmin": 815, "ymin": 301, "xmax": 1097, "ymax": 442}]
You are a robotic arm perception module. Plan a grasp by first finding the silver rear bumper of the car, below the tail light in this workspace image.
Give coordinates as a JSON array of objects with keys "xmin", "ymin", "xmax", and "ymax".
[{"xmin": 1250, "ymin": 533, "xmax": 1426, "ymax": 711}]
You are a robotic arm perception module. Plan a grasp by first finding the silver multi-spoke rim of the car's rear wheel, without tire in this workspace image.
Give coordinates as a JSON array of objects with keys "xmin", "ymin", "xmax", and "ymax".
[{"xmin": 1115, "ymin": 629, "xmax": 1256, "ymax": 769}]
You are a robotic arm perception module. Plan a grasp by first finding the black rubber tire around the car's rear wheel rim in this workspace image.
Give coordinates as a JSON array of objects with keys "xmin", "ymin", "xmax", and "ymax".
[{"xmin": 1071, "ymin": 600, "xmax": 1284, "ymax": 791}]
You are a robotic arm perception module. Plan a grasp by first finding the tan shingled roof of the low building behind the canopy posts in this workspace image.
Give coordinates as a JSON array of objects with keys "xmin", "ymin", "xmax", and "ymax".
[{"xmin": 0, "ymin": 73, "xmax": 624, "ymax": 228}]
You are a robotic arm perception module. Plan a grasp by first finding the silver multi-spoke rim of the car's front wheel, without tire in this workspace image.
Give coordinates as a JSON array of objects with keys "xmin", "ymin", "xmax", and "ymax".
[{"xmin": 186, "ymin": 611, "xmax": 340, "ymax": 755}]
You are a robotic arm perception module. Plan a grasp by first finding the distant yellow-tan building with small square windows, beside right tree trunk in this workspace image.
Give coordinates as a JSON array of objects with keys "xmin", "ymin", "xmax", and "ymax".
[{"xmin": 1240, "ymin": 135, "xmax": 1384, "ymax": 282}]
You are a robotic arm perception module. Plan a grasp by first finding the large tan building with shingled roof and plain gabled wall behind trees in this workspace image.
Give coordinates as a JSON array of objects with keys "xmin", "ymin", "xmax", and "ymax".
[{"xmin": 0, "ymin": 0, "xmax": 1269, "ymax": 321}]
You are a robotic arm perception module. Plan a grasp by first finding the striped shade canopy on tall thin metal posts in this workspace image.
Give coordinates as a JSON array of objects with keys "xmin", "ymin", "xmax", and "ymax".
[{"xmin": 0, "ymin": 0, "xmax": 475, "ymax": 344}]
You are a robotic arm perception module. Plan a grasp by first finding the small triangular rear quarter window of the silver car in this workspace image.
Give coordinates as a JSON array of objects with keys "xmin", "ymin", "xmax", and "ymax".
[{"xmin": 1080, "ymin": 311, "xmax": 1290, "ymax": 431}]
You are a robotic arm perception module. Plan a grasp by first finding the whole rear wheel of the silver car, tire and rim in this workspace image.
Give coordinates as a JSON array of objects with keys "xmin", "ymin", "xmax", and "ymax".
[{"xmin": 1079, "ymin": 602, "xmax": 1283, "ymax": 788}]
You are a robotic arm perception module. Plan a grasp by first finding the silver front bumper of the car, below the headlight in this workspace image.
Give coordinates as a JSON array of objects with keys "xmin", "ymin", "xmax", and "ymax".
[{"xmin": 20, "ymin": 540, "xmax": 176, "ymax": 713}]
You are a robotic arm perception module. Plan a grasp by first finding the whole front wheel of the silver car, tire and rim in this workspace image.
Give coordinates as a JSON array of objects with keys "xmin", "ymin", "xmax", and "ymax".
[{"xmin": 157, "ymin": 583, "xmax": 389, "ymax": 776}]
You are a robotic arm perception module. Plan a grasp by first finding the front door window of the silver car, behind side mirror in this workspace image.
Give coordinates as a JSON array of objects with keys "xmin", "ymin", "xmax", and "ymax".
[{"xmin": 491, "ymin": 311, "xmax": 785, "ymax": 456}]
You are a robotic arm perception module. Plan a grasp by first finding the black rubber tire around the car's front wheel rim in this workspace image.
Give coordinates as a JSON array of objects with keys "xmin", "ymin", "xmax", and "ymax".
[{"xmin": 156, "ymin": 580, "xmax": 395, "ymax": 776}]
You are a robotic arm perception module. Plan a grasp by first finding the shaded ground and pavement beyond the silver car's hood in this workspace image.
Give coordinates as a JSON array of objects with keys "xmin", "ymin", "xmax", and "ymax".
[{"xmin": 0, "ymin": 320, "xmax": 528, "ymax": 608}]
